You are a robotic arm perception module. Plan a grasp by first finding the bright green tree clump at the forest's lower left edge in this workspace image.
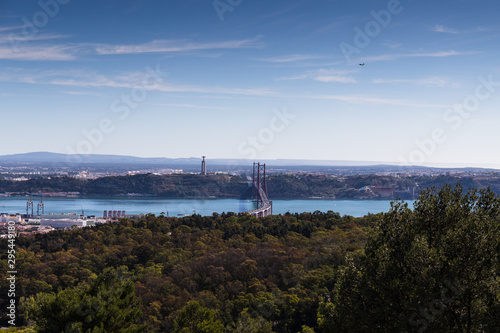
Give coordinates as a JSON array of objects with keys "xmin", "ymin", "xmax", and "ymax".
[{"xmin": 24, "ymin": 268, "xmax": 146, "ymax": 333}]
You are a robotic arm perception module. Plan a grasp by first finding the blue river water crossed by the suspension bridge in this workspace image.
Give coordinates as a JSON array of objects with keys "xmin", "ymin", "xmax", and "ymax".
[{"xmin": 0, "ymin": 197, "xmax": 413, "ymax": 217}]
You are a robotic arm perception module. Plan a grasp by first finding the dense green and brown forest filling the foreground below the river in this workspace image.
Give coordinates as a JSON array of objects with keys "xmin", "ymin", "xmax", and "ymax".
[{"xmin": 0, "ymin": 185, "xmax": 500, "ymax": 333}]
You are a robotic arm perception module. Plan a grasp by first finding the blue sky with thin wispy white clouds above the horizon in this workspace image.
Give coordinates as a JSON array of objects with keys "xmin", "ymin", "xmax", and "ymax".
[{"xmin": 0, "ymin": 0, "xmax": 500, "ymax": 167}]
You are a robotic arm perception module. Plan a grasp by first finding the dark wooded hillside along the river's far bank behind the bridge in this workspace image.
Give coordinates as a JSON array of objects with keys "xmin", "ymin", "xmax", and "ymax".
[{"xmin": 0, "ymin": 174, "xmax": 500, "ymax": 199}]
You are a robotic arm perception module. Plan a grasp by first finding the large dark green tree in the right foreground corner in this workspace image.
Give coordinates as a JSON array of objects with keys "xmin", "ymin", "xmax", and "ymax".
[{"xmin": 319, "ymin": 185, "xmax": 500, "ymax": 332}]
